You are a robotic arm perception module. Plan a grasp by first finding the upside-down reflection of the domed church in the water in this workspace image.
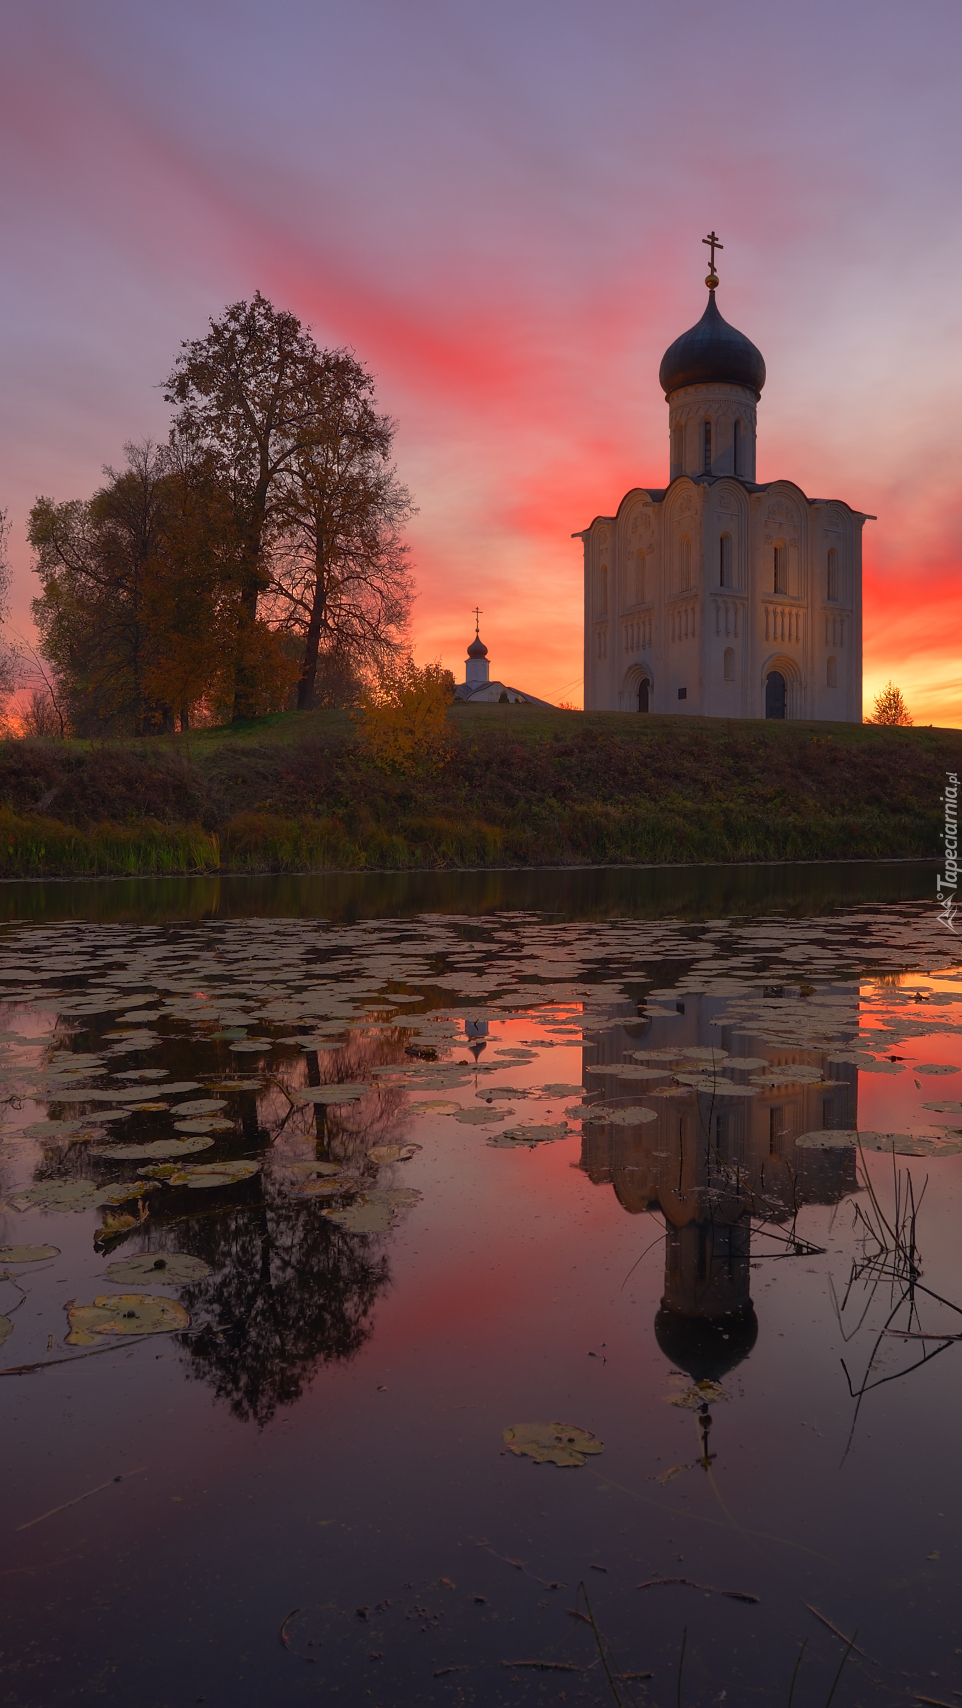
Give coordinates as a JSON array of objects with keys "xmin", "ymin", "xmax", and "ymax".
[{"xmin": 581, "ymin": 994, "xmax": 858, "ymax": 1382}]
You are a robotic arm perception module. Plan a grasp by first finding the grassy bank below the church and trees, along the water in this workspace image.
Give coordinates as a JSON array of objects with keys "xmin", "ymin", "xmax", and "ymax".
[{"xmin": 0, "ymin": 705, "xmax": 962, "ymax": 878}]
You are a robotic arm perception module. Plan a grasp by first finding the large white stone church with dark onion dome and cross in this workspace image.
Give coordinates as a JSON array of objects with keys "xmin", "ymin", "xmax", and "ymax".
[{"xmin": 572, "ymin": 239, "xmax": 875, "ymax": 722}]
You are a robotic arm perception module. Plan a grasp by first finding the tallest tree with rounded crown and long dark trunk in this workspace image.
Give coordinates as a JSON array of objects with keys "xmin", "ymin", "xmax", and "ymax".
[{"xmin": 164, "ymin": 290, "xmax": 328, "ymax": 717}]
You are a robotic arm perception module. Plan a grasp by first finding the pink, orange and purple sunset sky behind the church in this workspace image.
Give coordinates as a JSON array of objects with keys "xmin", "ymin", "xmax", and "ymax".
[{"xmin": 0, "ymin": 0, "xmax": 962, "ymax": 726}]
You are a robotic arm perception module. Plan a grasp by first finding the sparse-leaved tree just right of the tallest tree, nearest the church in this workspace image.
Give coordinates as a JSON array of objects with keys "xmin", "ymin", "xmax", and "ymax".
[{"xmin": 270, "ymin": 350, "xmax": 415, "ymax": 711}]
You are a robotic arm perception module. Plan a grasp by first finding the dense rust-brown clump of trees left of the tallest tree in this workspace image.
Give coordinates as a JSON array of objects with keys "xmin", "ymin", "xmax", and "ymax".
[{"xmin": 29, "ymin": 441, "xmax": 296, "ymax": 734}]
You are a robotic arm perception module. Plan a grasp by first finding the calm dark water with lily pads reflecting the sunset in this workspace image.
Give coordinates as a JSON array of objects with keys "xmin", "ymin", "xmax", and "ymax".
[{"xmin": 0, "ymin": 866, "xmax": 962, "ymax": 1708}]
